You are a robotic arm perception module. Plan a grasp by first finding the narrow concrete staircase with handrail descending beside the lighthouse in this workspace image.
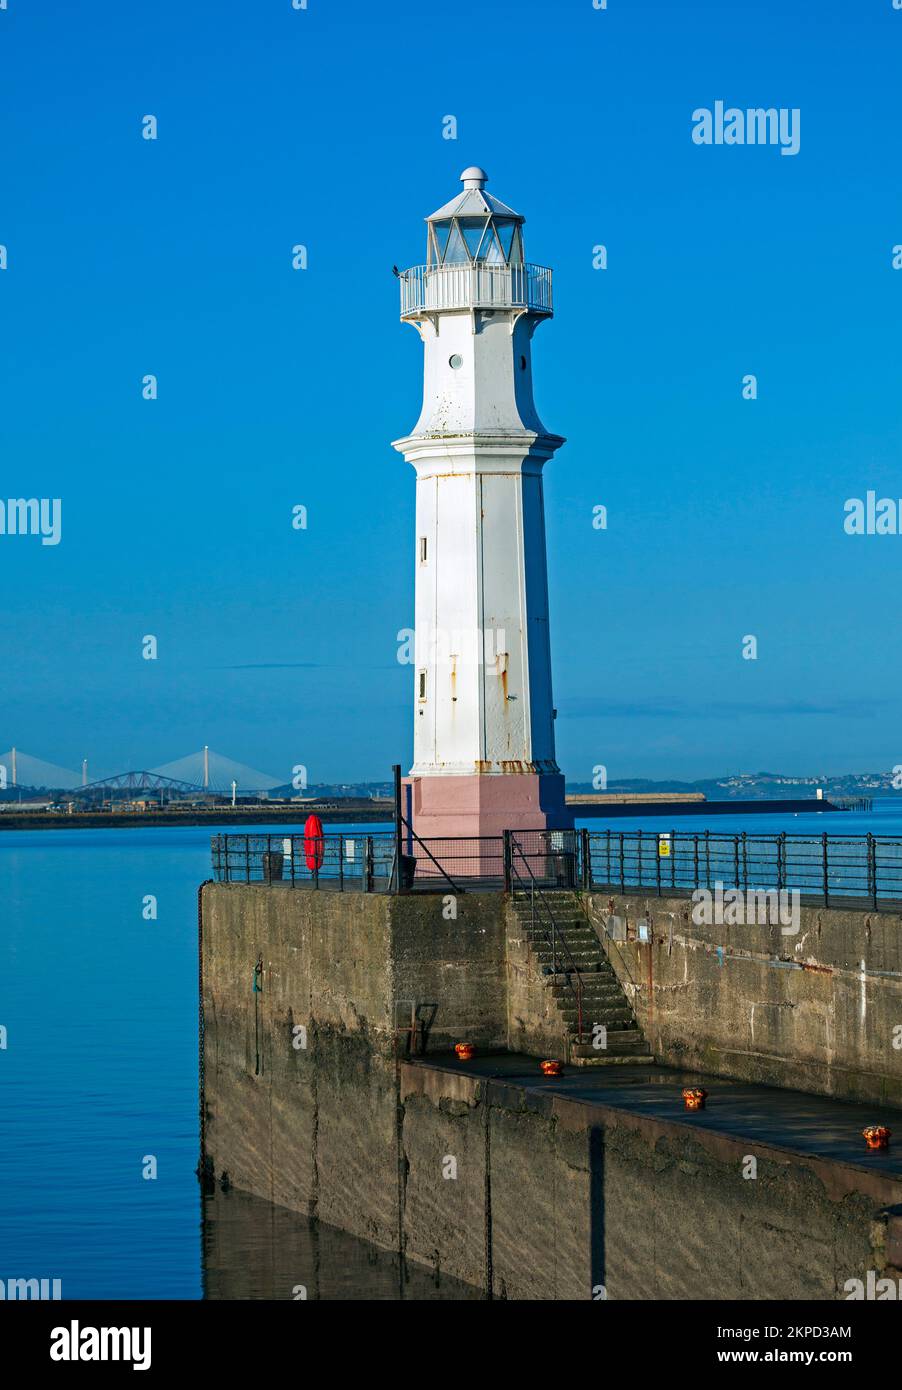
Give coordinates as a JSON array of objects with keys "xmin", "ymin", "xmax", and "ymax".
[{"xmin": 511, "ymin": 888, "xmax": 655, "ymax": 1066}]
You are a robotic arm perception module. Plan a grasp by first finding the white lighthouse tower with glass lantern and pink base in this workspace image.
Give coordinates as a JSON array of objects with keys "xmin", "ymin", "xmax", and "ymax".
[{"xmin": 393, "ymin": 168, "xmax": 573, "ymax": 837}]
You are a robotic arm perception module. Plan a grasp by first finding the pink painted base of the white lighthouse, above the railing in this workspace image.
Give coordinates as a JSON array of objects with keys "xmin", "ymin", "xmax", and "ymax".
[{"xmin": 404, "ymin": 773, "xmax": 573, "ymax": 840}]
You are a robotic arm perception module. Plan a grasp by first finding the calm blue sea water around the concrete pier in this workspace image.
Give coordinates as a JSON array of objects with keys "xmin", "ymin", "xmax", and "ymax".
[{"xmin": 0, "ymin": 802, "xmax": 902, "ymax": 1298}]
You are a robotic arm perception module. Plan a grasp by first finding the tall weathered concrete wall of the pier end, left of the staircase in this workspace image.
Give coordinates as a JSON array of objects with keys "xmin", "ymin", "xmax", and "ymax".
[{"xmin": 203, "ymin": 884, "xmax": 506, "ymax": 1247}]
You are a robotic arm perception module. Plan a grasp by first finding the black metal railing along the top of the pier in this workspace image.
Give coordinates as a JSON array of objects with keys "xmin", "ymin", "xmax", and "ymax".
[{"xmin": 213, "ymin": 830, "xmax": 902, "ymax": 909}]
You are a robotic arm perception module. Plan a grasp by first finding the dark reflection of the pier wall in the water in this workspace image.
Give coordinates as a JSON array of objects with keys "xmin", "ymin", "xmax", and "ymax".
[{"xmin": 203, "ymin": 1188, "xmax": 482, "ymax": 1302}]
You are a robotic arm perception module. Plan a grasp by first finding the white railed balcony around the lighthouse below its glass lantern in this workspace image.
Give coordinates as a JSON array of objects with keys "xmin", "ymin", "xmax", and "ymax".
[{"xmin": 400, "ymin": 263, "xmax": 552, "ymax": 318}]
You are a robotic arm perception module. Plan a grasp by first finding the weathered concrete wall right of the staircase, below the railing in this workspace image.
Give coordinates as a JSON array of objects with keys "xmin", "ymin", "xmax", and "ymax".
[{"xmin": 588, "ymin": 894, "xmax": 902, "ymax": 1106}]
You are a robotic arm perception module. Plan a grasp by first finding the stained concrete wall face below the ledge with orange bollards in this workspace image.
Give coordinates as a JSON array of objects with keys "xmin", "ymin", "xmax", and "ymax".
[{"xmin": 402, "ymin": 1062, "xmax": 902, "ymax": 1300}]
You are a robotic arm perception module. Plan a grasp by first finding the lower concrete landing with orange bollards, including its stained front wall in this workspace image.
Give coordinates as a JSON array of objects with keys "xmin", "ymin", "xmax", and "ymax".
[{"xmin": 402, "ymin": 1055, "xmax": 902, "ymax": 1300}]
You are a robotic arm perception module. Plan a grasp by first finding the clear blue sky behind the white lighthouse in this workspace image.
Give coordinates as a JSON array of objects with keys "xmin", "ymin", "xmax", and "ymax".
[{"xmin": 0, "ymin": 0, "xmax": 902, "ymax": 781}]
